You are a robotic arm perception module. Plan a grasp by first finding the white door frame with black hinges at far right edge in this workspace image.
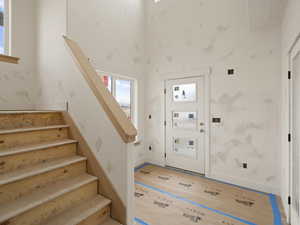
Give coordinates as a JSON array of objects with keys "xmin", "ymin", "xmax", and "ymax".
[{"xmin": 288, "ymin": 33, "xmax": 300, "ymax": 224}]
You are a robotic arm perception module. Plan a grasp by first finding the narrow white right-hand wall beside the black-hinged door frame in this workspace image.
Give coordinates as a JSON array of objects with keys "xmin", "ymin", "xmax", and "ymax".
[{"xmin": 281, "ymin": 0, "xmax": 300, "ymax": 219}]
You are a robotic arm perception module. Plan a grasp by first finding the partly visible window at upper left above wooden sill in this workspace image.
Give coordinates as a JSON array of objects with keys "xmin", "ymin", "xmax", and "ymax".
[{"xmin": 0, "ymin": 0, "xmax": 9, "ymax": 54}]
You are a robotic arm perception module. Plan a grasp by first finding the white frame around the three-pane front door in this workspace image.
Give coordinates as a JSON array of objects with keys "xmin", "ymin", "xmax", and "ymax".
[{"xmin": 163, "ymin": 68, "xmax": 211, "ymax": 177}]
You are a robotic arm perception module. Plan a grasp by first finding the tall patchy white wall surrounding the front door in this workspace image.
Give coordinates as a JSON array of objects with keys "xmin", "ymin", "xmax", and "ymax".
[{"xmin": 145, "ymin": 0, "xmax": 281, "ymax": 193}]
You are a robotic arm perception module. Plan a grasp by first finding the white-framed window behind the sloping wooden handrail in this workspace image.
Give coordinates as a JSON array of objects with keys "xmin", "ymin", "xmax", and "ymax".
[{"xmin": 101, "ymin": 74, "xmax": 136, "ymax": 125}]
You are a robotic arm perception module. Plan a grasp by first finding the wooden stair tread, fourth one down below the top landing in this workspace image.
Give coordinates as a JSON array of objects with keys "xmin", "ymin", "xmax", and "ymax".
[{"xmin": 0, "ymin": 174, "xmax": 98, "ymax": 223}]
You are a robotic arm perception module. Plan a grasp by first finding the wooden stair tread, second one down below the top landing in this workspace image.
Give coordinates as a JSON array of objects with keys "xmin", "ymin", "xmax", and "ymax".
[{"xmin": 0, "ymin": 139, "xmax": 78, "ymax": 157}]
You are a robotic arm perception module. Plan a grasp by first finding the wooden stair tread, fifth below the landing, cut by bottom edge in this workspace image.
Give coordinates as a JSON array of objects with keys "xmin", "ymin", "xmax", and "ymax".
[{"xmin": 41, "ymin": 195, "xmax": 111, "ymax": 225}]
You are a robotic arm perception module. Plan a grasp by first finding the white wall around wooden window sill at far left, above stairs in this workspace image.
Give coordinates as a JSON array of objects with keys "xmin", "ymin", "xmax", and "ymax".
[{"xmin": 0, "ymin": 0, "xmax": 37, "ymax": 110}]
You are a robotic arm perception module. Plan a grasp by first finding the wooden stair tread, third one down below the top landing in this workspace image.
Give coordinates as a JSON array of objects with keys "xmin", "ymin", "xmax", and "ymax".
[{"xmin": 0, "ymin": 156, "xmax": 86, "ymax": 185}]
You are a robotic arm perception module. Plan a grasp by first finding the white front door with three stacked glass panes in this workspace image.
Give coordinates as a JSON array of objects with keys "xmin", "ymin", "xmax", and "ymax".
[{"xmin": 166, "ymin": 77, "xmax": 205, "ymax": 174}]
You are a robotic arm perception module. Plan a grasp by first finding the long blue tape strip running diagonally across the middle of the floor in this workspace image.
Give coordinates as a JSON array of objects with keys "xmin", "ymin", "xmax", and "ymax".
[{"xmin": 135, "ymin": 181, "xmax": 258, "ymax": 225}]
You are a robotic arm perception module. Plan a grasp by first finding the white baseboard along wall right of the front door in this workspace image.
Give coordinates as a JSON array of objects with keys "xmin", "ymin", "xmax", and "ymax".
[{"xmin": 207, "ymin": 173, "xmax": 280, "ymax": 195}]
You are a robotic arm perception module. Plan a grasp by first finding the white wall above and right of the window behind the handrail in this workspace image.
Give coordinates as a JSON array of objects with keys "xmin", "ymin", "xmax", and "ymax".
[{"xmin": 68, "ymin": 0, "xmax": 145, "ymax": 164}]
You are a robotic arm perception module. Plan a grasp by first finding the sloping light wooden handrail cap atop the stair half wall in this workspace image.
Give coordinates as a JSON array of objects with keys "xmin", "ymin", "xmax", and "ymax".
[{"xmin": 63, "ymin": 36, "xmax": 137, "ymax": 143}]
